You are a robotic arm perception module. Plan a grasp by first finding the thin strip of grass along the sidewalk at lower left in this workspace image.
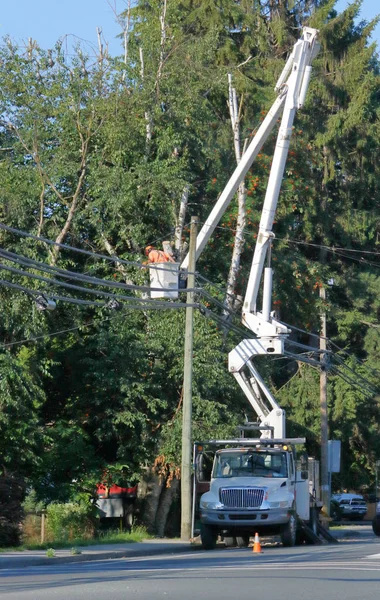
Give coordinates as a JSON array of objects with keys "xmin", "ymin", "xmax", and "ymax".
[{"xmin": 0, "ymin": 526, "xmax": 151, "ymax": 552}]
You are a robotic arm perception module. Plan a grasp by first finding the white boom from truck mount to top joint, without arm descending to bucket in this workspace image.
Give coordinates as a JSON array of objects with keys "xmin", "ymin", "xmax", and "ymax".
[{"xmin": 228, "ymin": 28, "xmax": 319, "ymax": 438}]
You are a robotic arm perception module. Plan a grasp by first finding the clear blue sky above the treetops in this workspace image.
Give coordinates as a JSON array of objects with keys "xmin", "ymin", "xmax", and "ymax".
[{"xmin": 0, "ymin": 0, "xmax": 380, "ymax": 55}]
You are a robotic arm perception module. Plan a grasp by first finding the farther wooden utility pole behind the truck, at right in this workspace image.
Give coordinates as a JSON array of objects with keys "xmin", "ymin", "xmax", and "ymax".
[{"xmin": 319, "ymin": 286, "xmax": 330, "ymax": 517}]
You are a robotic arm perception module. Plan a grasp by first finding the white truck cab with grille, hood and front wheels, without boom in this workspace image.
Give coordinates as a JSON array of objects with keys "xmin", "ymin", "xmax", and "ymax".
[{"xmin": 194, "ymin": 439, "xmax": 310, "ymax": 549}]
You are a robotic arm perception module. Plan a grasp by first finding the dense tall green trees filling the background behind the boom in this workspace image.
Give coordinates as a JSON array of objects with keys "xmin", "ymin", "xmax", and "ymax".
[{"xmin": 0, "ymin": 0, "xmax": 380, "ymax": 506}]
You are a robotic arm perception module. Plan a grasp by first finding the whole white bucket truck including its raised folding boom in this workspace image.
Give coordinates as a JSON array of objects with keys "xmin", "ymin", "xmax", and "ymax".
[{"xmin": 181, "ymin": 27, "xmax": 319, "ymax": 549}]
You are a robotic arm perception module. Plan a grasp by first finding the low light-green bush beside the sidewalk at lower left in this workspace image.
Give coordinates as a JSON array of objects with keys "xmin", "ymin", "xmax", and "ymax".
[{"xmin": 46, "ymin": 502, "xmax": 96, "ymax": 542}]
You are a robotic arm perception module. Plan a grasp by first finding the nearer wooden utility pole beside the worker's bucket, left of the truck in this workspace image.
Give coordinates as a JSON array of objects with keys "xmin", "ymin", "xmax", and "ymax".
[{"xmin": 181, "ymin": 217, "xmax": 198, "ymax": 541}]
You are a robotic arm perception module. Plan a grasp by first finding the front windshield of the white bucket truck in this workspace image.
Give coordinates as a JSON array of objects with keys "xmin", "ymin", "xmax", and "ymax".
[{"xmin": 213, "ymin": 450, "xmax": 288, "ymax": 478}]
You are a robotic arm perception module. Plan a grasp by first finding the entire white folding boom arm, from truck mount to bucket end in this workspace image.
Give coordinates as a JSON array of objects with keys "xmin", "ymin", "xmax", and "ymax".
[{"xmin": 181, "ymin": 27, "xmax": 319, "ymax": 439}]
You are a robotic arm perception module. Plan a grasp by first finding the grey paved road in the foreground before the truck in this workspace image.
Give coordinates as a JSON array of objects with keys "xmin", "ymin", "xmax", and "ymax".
[{"xmin": 0, "ymin": 536, "xmax": 380, "ymax": 600}]
